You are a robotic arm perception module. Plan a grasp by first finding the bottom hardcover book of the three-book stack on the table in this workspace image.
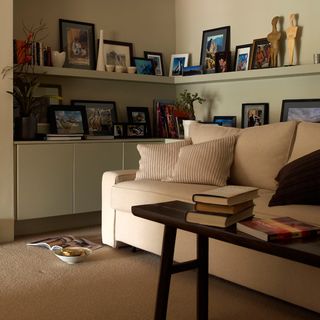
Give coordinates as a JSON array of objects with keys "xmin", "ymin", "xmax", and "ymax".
[{"xmin": 186, "ymin": 206, "xmax": 253, "ymax": 228}]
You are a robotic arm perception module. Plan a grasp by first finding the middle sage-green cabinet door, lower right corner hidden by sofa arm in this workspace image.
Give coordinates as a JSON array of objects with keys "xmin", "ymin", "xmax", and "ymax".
[{"xmin": 75, "ymin": 142, "xmax": 122, "ymax": 213}]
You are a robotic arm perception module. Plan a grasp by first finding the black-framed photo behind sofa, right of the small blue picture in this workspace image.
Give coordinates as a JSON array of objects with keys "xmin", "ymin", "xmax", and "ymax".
[{"xmin": 241, "ymin": 103, "xmax": 269, "ymax": 128}]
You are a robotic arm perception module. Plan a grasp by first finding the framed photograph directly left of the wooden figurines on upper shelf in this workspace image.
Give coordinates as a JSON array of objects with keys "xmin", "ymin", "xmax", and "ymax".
[{"xmin": 250, "ymin": 38, "xmax": 271, "ymax": 69}]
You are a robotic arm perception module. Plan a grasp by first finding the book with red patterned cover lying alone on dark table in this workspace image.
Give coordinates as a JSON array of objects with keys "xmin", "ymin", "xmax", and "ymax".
[{"xmin": 237, "ymin": 217, "xmax": 320, "ymax": 241}]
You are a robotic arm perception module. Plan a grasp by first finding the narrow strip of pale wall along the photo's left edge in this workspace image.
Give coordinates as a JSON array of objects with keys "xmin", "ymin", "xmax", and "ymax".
[{"xmin": 0, "ymin": 0, "xmax": 14, "ymax": 243}]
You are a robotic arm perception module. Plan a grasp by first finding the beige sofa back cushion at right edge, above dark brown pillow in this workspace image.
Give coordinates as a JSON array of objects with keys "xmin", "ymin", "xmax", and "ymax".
[{"xmin": 289, "ymin": 122, "xmax": 320, "ymax": 162}]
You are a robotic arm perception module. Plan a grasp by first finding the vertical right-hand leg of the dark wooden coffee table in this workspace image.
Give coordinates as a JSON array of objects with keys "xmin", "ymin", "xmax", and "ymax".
[{"xmin": 197, "ymin": 235, "xmax": 209, "ymax": 320}]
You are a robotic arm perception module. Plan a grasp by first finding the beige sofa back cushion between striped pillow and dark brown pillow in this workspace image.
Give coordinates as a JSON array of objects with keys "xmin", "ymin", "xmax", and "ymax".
[{"xmin": 230, "ymin": 121, "xmax": 297, "ymax": 190}]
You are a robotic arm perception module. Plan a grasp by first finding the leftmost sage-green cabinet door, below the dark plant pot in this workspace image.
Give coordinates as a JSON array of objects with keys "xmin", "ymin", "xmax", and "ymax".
[{"xmin": 16, "ymin": 144, "xmax": 73, "ymax": 220}]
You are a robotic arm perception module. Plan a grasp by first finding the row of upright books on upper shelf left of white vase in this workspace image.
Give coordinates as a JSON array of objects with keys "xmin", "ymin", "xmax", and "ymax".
[{"xmin": 13, "ymin": 39, "xmax": 52, "ymax": 66}]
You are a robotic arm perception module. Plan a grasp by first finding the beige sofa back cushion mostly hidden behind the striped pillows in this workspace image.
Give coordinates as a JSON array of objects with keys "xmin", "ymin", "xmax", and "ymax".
[{"xmin": 189, "ymin": 122, "xmax": 241, "ymax": 144}]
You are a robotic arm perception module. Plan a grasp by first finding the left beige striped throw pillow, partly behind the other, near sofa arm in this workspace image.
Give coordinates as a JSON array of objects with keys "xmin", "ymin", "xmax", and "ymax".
[{"xmin": 135, "ymin": 139, "xmax": 191, "ymax": 180}]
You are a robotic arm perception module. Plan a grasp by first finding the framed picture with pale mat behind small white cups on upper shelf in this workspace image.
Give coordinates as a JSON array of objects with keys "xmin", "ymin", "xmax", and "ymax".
[{"xmin": 103, "ymin": 40, "xmax": 133, "ymax": 67}]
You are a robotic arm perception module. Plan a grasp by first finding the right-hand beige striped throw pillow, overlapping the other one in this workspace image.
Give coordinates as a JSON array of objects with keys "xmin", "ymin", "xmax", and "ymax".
[{"xmin": 167, "ymin": 135, "xmax": 237, "ymax": 186}]
